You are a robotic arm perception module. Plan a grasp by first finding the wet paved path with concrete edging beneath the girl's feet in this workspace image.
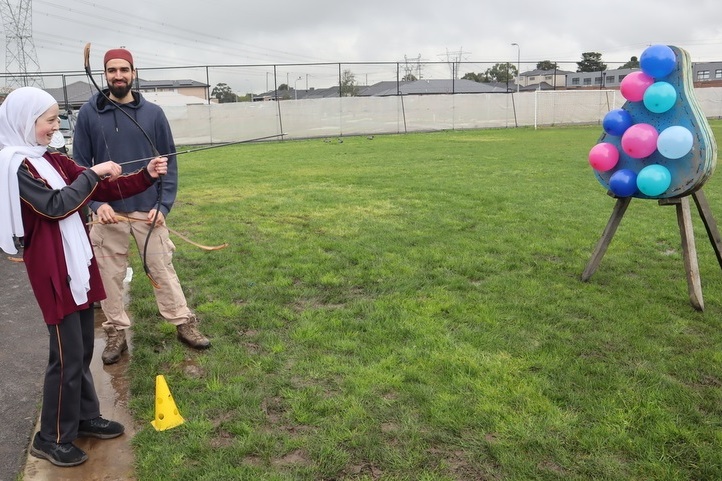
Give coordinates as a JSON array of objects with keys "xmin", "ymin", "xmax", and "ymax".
[{"xmin": 0, "ymin": 257, "xmax": 136, "ymax": 481}]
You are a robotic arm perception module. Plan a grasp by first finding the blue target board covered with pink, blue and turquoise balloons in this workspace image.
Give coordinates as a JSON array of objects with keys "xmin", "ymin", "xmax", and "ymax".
[{"xmin": 589, "ymin": 45, "xmax": 717, "ymax": 199}]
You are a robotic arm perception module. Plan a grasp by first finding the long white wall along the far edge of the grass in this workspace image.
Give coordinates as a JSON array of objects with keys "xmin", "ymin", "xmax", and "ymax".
[{"xmin": 163, "ymin": 88, "xmax": 722, "ymax": 145}]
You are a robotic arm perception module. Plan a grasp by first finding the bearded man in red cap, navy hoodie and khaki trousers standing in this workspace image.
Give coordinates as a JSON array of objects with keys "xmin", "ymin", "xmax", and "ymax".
[{"xmin": 73, "ymin": 48, "xmax": 210, "ymax": 364}]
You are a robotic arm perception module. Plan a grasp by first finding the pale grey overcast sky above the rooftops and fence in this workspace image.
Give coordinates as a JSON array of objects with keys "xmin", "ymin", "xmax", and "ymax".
[{"xmin": 8, "ymin": 0, "xmax": 722, "ymax": 93}]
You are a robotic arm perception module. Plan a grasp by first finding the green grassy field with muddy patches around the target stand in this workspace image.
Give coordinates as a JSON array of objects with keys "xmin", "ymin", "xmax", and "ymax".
[{"xmin": 125, "ymin": 121, "xmax": 722, "ymax": 481}]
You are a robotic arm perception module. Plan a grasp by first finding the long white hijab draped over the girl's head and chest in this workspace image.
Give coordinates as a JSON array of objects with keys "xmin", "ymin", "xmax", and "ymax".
[{"xmin": 0, "ymin": 87, "xmax": 93, "ymax": 305}]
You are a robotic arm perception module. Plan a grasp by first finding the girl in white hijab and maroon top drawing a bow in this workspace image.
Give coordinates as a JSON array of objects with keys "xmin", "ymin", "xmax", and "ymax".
[{"xmin": 0, "ymin": 87, "xmax": 167, "ymax": 466}]
